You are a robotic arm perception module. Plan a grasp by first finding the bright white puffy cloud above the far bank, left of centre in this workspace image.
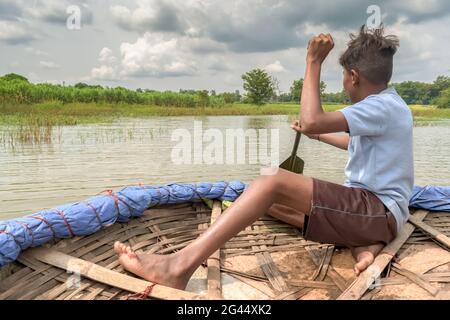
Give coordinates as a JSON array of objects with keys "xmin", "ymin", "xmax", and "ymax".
[{"xmin": 120, "ymin": 33, "xmax": 196, "ymax": 78}]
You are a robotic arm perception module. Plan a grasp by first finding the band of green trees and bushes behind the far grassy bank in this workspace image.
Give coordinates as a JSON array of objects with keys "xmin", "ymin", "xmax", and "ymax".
[{"xmin": 0, "ymin": 69, "xmax": 450, "ymax": 108}]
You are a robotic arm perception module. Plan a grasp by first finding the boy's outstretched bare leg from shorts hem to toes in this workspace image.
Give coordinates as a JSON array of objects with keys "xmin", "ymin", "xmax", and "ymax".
[{"xmin": 114, "ymin": 169, "xmax": 313, "ymax": 289}]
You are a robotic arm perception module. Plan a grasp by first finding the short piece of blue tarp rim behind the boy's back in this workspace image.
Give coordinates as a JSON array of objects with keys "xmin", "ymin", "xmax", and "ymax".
[{"xmin": 409, "ymin": 186, "xmax": 450, "ymax": 212}]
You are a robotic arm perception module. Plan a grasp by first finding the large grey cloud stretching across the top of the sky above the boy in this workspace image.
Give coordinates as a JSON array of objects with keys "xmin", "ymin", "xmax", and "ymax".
[{"xmin": 106, "ymin": 0, "xmax": 450, "ymax": 52}]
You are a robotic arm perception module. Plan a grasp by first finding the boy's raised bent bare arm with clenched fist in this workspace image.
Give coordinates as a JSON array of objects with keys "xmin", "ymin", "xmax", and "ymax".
[{"xmin": 300, "ymin": 34, "xmax": 349, "ymax": 134}]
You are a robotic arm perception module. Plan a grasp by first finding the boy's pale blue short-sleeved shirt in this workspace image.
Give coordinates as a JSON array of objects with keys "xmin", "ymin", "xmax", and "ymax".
[{"xmin": 339, "ymin": 88, "xmax": 414, "ymax": 231}]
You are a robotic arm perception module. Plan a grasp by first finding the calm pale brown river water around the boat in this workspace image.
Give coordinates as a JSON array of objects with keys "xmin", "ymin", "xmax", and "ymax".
[{"xmin": 0, "ymin": 116, "xmax": 450, "ymax": 219}]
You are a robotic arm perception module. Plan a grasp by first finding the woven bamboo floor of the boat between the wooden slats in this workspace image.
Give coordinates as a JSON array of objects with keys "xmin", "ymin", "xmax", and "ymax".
[{"xmin": 0, "ymin": 203, "xmax": 450, "ymax": 300}]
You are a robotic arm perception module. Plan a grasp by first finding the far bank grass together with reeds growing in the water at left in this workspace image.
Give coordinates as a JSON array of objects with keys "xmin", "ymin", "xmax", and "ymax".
[{"xmin": 0, "ymin": 101, "xmax": 450, "ymax": 146}]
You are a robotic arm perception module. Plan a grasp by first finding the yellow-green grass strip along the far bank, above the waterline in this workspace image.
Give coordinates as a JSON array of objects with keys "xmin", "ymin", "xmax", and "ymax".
[{"xmin": 0, "ymin": 102, "xmax": 450, "ymax": 126}]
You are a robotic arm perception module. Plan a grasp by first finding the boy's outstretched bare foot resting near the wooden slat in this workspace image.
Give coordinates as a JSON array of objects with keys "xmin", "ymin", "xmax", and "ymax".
[{"xmin": 114, "ymin": 241, "xmax": 192, "ymax": 290}]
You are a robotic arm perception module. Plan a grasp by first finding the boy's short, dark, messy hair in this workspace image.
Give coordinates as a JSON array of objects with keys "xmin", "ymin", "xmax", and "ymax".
[{"xmin": 339, "ymin": 25, "xmax": 400, "ymax": 85}]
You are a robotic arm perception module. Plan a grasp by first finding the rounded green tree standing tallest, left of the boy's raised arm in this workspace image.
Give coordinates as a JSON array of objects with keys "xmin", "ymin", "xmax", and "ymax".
[{"xmin": 242, "ymin": 69, "xmax": 275, "ymax": 105}]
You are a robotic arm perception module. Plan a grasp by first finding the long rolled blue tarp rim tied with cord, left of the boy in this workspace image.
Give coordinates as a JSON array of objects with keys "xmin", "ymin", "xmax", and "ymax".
[{"xmin": 0, "ymin": 181, "xmax": 246, "ymax": 266}]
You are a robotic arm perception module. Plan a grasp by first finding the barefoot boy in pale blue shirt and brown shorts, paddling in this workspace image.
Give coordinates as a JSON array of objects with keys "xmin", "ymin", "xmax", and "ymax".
[{"xmin": 114, "ymin": 27, "xmax": 413, "ymax": 289}]
